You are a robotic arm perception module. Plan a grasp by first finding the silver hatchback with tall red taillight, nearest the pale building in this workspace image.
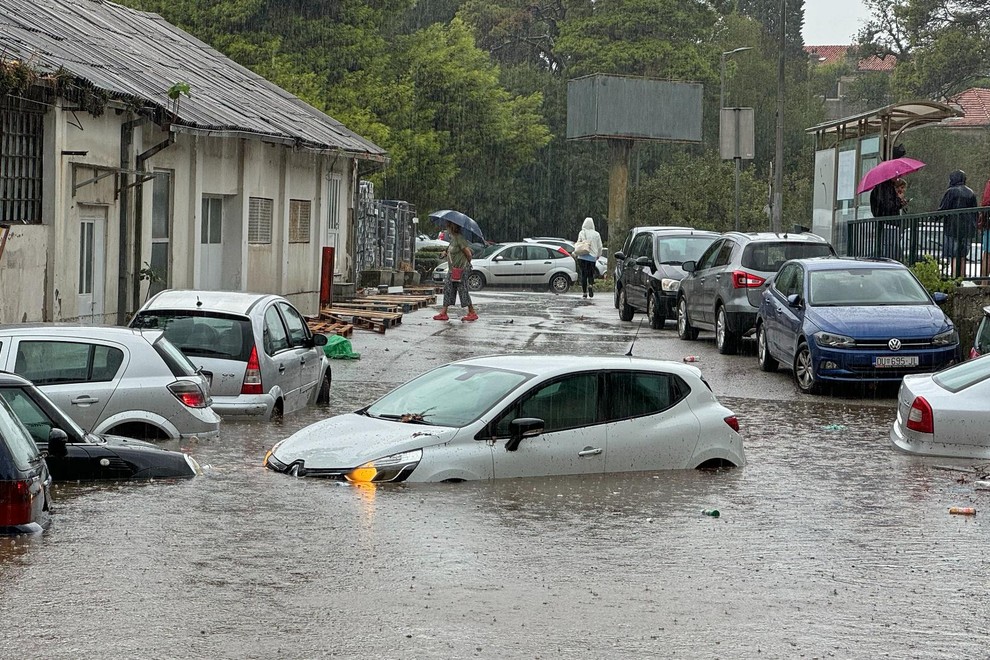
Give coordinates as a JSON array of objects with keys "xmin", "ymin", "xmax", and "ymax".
[{"xmin": 131, "ymin": 290, "xmax": 331, "ymax": 419}]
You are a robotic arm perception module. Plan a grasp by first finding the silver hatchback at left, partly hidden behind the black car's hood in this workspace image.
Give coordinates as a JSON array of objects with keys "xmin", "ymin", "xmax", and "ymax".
[{"xmin": 0, "ymin": 323, "xmax": 220, "ymax": 440}]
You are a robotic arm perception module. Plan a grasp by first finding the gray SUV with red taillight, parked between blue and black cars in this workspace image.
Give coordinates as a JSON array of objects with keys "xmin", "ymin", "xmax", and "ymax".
[{"xmin": 677, "ymin": 231, "xmax": 835, "ymax": 355}]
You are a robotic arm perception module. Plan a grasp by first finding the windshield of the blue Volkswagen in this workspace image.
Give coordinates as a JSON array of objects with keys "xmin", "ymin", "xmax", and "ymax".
[{"xmin": 808, "ymin": 267, "xmax": 931, "ymax": 307}]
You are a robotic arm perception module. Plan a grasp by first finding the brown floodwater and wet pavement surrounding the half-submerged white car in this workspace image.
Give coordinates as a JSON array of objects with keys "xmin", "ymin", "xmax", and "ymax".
[{"xmin": 0, "ymin": 292, "xmax": 990, "ymax": 658}]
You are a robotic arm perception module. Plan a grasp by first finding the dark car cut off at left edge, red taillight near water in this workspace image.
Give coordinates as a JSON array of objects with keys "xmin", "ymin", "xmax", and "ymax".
[{"xmin": 0, "ymin": 390, "xmax": 52, "ymax": 534}]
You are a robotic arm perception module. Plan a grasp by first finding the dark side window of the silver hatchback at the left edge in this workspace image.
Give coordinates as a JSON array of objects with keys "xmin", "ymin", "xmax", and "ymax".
[{"xmin": 14, "ymin": 341, "xmax": 124, "ymax": 385}]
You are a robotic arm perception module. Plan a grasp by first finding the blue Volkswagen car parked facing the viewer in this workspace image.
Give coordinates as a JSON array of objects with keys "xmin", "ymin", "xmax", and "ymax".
[{"xmin": 756, "ymin": 257, "xmax": 959, "ymax": 394}]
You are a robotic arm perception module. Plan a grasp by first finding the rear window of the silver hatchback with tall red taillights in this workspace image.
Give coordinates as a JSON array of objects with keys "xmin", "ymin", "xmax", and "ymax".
[{"xmin": 131, "ymin": 310, "xmax": 254, "ymax": 362}]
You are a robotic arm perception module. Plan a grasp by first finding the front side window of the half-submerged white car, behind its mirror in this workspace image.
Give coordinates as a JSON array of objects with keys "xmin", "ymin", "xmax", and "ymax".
[{"xmin": 495, "ymin": 373, "xmax": 598, "ymax": 437}]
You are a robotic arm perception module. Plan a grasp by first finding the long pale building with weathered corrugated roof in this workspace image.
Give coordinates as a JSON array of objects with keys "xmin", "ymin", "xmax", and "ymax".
[{"xmin": 0, "ymin": 0, "xmax": 387, "ymax": 323}]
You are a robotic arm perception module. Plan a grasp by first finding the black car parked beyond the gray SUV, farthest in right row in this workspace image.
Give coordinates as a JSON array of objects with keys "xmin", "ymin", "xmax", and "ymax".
[{"xmin": 615, "ymin": 227, "xmax": 721, "ymax": 329}]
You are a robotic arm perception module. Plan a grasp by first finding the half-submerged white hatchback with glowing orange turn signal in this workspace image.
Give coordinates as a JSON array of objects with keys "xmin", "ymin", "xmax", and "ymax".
[{"xmin": 265, "ymin": 355, "xmax": 746, "ymax": 483}]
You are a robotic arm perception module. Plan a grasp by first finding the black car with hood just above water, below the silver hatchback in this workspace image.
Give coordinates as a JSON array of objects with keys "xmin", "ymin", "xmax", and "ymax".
[{"xmin": 0, "ymin": 372, "xmax": 201, "ymax": 481}]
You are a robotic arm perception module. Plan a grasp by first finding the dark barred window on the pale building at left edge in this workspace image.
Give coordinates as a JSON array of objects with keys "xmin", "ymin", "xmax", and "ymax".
[{"xmin": 0, "ymin": 98, "xmax": 45, "ymax": 224}]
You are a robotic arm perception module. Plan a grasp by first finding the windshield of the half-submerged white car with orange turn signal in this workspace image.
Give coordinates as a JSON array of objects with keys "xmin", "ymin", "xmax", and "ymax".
[{"xmin": 365, "ymin": 364, "xmax": 532, "ymax": 427}]
